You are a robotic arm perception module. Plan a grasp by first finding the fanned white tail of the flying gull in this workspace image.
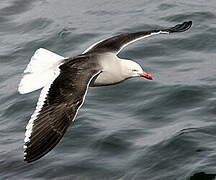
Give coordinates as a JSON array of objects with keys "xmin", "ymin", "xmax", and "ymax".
[{"xmin": 18, "ymin": 48, "xmax": 65, "ymax": 94}]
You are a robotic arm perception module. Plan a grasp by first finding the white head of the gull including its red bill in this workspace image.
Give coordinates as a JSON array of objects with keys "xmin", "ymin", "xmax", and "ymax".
[{"xmin": 121, "ymin": 60, "xmax": 153, "ymax": 80}]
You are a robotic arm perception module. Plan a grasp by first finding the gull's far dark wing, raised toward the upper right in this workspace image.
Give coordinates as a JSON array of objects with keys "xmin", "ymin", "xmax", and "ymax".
[{"xmin": 83, "ymin": 21, "xmax": 192, "ymax": 54}]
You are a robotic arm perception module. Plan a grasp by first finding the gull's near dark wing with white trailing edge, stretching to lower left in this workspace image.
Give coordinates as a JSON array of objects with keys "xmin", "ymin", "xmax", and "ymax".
[{"xmin": 24, "ymin": 57, "xmax": 100, "ymax": 162}]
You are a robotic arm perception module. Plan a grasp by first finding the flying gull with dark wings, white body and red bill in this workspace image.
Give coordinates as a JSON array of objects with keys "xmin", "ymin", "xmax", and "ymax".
[{"xmin": 18, "ymin": 21, "xmax": 192, "ymax": 162}]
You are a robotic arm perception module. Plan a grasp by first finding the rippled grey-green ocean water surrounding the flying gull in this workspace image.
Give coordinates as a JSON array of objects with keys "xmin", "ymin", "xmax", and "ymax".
[{"xmin": 0, "ymin": 0, "xmax": 216, "ymax": 180}]
